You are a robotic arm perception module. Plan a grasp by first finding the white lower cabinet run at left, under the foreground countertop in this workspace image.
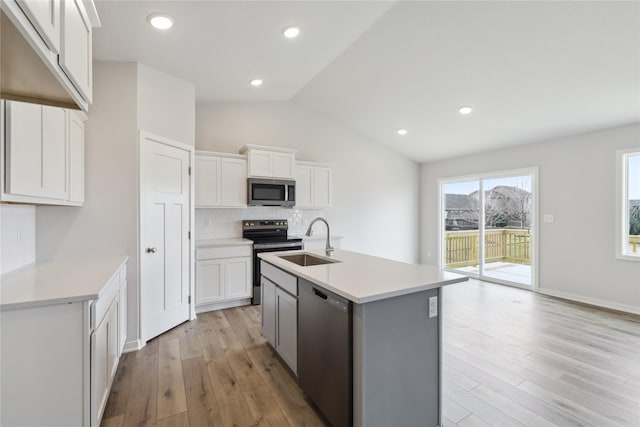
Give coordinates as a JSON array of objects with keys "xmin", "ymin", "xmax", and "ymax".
[{"xmin": 0, "ymin": 264, "xmax": 126, "ymax": 427}]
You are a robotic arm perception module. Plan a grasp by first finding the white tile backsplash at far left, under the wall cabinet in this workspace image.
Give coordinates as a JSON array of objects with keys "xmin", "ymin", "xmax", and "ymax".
[{"xmin": 0, "ymin": 204, "xmax": 36, "ymax": 274}]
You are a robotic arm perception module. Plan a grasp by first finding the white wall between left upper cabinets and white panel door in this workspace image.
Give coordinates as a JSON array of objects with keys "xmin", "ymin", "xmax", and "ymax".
[{"xmin": 37, "ymin": 62, "xmax": 138, "ymax": 346}]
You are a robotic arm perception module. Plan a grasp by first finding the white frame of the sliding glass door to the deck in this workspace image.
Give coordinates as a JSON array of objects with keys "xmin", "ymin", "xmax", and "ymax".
[{"xmin": 438, "ymin": 166, "xmax": 540, "ymax": 292}]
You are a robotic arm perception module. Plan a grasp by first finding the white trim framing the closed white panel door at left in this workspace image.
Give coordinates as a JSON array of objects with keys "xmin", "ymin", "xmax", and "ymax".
[{"xmin": 136, "ymin": 129, "xmax": 196, "ymax": 349}]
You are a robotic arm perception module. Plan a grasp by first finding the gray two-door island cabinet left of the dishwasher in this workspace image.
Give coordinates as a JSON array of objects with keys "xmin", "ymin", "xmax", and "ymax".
[{"xmin": 260, "ymin": 261, "xmax": 298, "ymax": 374}]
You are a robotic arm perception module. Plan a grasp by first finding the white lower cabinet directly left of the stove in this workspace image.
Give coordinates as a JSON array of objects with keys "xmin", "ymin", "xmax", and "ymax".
[{"xmin": 196, "ymin": 245, "xmax": 252, "ymax": 312}]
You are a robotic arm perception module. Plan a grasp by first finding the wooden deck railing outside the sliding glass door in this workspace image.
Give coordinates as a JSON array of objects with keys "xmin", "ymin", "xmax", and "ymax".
[{"xmin": 445, "ymin": 228, "xmax": 531, "ymax": 268}]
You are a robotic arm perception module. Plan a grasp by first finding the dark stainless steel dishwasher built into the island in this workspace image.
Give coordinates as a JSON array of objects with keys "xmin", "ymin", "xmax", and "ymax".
[{"xmin": 298, "ymin": 279, "xmax": 353, "ymax": 427}]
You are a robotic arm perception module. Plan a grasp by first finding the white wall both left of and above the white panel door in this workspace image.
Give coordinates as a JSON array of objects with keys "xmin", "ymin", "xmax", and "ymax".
[{"xmin": 36, "ymin": 62, "xmax": 195, "ymax": 346}]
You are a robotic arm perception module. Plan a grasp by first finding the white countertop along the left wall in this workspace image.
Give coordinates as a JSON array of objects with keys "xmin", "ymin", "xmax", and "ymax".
[{"xmin": 0, "ymin": 256, "xmax": 129, "ymax": 310}]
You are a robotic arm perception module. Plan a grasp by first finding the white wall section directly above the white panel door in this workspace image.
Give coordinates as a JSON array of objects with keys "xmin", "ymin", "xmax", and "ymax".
[{"xmin": 137, "ymin": 64, "xmax": 196, "ymax": 147}]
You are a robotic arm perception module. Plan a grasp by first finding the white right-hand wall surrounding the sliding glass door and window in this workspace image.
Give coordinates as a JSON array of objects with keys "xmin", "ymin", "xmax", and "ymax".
[{"xmin": 421, "ymin": 125, "xmax": 640, "ymax": 313}]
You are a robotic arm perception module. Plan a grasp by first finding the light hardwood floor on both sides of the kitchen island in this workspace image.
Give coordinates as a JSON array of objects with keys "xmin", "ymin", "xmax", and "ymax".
[{"xmin": 102, "ymin": 280, "xmax": 640, "ymax": 427}]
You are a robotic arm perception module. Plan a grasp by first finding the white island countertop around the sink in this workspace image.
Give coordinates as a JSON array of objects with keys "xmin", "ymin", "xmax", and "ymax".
[{"xmin": 258, "ymin": 250, "xmax": 469, "ymax": 304}]
